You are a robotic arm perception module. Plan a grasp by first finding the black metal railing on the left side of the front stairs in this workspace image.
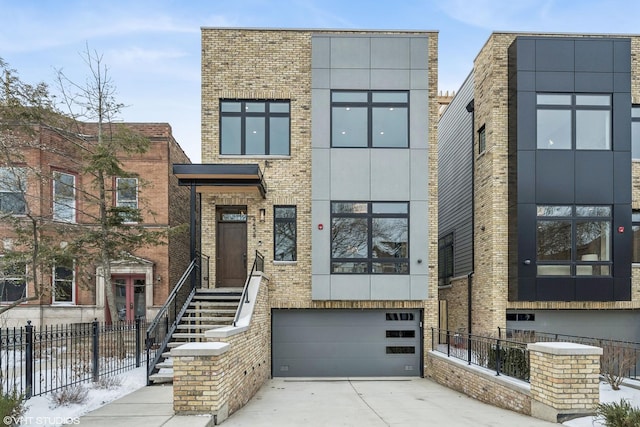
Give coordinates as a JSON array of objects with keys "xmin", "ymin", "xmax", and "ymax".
[{"xmin": 145, "ymin": 254, "xmax": 209, "ymax": 385}]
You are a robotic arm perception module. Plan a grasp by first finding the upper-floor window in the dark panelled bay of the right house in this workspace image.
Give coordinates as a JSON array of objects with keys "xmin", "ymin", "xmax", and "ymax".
[{"xmin": 537, "ymin": 93, "xmax": 611, "ymax": 150}]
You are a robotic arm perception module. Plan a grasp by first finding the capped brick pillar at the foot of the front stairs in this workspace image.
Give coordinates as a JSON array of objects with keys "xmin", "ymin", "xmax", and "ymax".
[{"xmin": 171, "ymin": 342, "xmax": 229, "ymax": 424}]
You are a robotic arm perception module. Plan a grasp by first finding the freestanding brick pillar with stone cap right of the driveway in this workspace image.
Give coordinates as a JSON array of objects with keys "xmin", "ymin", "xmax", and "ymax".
[{"xmin": 527, "ymin": 342, "xmax": 602, "ymax": 422}]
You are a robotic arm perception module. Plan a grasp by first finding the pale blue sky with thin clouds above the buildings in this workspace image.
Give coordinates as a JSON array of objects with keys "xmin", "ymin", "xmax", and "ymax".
[{"xmin": 0, "ymin": 0, "xmax": 640, "ymax": 163}]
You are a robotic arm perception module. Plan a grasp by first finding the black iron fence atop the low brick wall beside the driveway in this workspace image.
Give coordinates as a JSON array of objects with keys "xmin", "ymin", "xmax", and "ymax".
[{"xmin": 431, "ymin": 328, "xmax": 529, "ymax": 381}]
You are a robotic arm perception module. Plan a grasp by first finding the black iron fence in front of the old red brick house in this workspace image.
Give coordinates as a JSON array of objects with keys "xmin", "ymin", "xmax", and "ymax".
[{"xmin": 0, "ymin": 319, "xmax": 147, "ymax": 399}]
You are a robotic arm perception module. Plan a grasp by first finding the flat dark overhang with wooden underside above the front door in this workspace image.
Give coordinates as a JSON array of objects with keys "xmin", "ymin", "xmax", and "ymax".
[{"xmin": 173, "ymin": 163, "xmax": 267, "ymax": 199}]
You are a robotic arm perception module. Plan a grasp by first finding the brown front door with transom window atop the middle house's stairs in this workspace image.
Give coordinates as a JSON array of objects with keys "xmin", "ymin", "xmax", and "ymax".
[{"xmin": 216, "ymin": 206, "xmax": 247, "ymax": 288}]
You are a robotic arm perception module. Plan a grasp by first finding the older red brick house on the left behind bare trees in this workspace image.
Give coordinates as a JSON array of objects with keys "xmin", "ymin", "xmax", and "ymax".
[{"xmin": 0, "ymin": 123, "xmax": 190, "ymax": 326}]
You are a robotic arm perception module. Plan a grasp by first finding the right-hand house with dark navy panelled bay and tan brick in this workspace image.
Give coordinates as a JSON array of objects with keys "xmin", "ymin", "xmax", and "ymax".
[{"xmin": 438, "ymin": 33, "xmax": 640, "ymax": 341}]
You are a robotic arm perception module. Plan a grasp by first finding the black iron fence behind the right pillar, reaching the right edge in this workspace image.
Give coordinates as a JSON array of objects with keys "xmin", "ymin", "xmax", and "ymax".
[{"xmin": 498, "ymin": 328, "xmax": 640, "ymax": 378}]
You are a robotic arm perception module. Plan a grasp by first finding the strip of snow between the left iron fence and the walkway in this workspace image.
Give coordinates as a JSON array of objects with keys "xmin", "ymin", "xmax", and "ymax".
[{"xmin": 23, "ymin": 366, "xmax": 147, "ymax": 426}]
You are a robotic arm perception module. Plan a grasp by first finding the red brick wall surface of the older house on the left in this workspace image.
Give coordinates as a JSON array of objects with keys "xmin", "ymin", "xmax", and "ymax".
[{"xmin": 0, "ymin": 123, "xmax": 190, "ymax": 325}]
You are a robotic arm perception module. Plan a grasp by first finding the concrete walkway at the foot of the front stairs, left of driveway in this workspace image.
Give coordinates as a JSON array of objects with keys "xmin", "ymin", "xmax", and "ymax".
[{"xmin": 79, "ymin": 385, "xmax": 213, "ymax": 427}]
